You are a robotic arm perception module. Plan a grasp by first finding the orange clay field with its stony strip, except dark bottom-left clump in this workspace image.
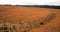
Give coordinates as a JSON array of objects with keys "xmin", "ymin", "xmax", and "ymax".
[{"xmin": 0, "ymin": 6, "xmax": 60, "ymax": 32}]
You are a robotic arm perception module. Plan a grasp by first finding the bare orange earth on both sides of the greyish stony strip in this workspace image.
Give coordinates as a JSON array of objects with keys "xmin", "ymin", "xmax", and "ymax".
[{"xmin": 0, "ymin": 6, "xmax": 60, "ymax": 32}]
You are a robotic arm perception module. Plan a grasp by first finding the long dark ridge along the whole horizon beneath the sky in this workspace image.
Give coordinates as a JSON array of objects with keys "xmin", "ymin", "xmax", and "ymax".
[{"xmin": 0, "ymin": 5, "xmax": 60, "ymax": 9}]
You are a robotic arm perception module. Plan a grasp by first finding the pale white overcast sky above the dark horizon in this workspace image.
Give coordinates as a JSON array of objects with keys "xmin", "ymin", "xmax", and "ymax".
[{"xmin": 0, "ymin": 0, "xmax": 60, "ymax": 6}]
